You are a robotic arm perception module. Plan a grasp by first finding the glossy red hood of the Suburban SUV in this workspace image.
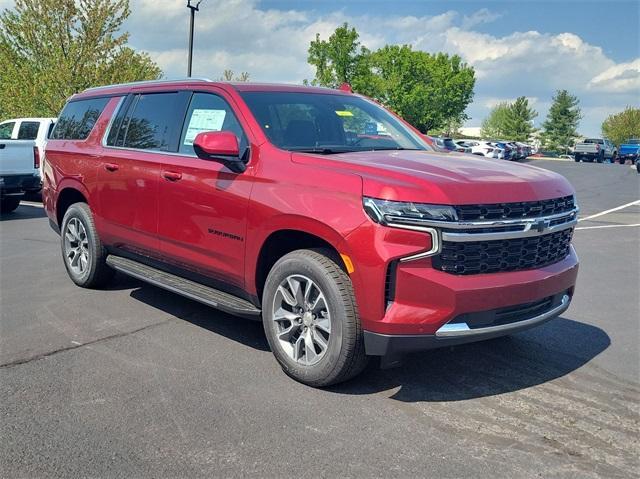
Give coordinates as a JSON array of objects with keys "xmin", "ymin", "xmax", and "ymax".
[{"xmin": 292, "ymin": 150, "xmax": 574, "ymax": 205}]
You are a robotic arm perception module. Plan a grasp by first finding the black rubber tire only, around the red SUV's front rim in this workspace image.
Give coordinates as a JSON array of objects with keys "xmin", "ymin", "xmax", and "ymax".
[{"xmin": 262, "ymin": 249, "xmax": 368, "ymax": 387}]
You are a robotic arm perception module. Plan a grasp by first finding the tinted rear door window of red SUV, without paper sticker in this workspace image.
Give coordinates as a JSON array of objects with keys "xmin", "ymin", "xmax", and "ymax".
[{"xmin": 120, "ymin": 93, "xmax": 182, "ymax": 151}]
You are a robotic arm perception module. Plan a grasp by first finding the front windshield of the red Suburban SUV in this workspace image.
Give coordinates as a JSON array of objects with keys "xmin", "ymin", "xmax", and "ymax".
[{"xmin": 242, "ymin": 92, "xmax": 431, "ymax": 154}]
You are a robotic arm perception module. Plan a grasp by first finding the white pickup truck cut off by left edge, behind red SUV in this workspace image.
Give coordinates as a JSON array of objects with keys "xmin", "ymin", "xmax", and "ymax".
[{"xmin": 0, "ymin": 118, "xmax": 55, "ymax": 213}]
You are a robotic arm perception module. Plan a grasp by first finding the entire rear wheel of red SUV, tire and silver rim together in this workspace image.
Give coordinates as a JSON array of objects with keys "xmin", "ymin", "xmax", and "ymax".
[{"xmin": 60, "ymin": 203, "xmax": 114, "ymax": 288}]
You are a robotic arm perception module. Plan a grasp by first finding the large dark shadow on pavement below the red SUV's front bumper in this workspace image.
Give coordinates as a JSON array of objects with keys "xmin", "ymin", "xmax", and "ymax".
[{"xmin": 329, "ymin": 318, "xmax": 611, "ymax": 402}]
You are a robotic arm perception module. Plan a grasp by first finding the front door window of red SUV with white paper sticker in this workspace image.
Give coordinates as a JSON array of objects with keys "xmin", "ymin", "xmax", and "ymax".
[{"xmin": 179, "ymin": 93, "xmax": 247, "ymax": 155}]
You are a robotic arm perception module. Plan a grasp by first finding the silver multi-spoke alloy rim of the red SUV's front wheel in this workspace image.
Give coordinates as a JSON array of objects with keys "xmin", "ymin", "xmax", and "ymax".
[{"xmin": 272, "ymin": 274, "xmax": 331, "ymax": 366}]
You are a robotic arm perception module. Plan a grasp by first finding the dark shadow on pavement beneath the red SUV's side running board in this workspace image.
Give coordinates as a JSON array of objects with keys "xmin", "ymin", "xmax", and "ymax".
[{"xmin": 127, "ymin": 282, "xmax": 269, "ymax": 351}]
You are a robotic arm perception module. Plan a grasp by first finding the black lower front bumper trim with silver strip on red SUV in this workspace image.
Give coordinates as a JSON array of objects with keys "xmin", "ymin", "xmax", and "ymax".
[{"xmin": 364, "ymin": 291, "xmax": 572, "ymax": 356}]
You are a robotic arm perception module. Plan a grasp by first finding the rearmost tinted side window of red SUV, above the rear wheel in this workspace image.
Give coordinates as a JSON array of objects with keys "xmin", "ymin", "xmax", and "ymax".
[{"xmin": 51, "ymin": 98, "xmax": 109, "ymax": 140}]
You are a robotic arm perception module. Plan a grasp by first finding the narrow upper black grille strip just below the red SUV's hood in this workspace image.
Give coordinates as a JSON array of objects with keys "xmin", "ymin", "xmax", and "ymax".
[{"xmin": 455, "ymin": 195, "xmax": 575, "ymax": 221}]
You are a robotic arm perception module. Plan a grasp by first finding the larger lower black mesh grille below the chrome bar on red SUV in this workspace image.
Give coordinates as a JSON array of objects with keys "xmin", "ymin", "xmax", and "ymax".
[{"xmin": 433, "ymin": 228, "xmax": 573, "ymax": 275}]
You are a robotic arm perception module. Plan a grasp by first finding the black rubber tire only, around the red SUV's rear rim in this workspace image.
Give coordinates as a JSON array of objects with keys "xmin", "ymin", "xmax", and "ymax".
[{"xmin": 60, "ymin": 203, "xmax": 114, "ymax": 288}]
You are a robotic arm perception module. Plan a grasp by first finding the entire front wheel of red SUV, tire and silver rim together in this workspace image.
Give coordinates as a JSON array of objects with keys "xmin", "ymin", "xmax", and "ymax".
[{"xmin": 262, "ymin": 250, "xmax": 367, "ymax": 387}]
